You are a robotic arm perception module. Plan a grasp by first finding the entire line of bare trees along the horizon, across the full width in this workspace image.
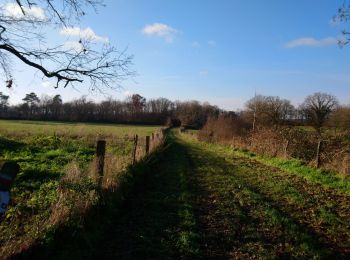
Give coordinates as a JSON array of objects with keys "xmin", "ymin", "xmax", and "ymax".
[{"xmin": 0, "ymin": 92, "xmax": 350, "ymax": 130}]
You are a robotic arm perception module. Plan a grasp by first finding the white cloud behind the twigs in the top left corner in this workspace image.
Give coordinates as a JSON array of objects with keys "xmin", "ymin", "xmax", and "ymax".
[{"xmin": 1, "ymin": 3, "xmax": 46, "ymax": 21}]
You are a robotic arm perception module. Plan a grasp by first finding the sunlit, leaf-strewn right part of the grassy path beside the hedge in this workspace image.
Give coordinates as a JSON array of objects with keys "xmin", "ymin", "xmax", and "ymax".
[{"xmin": 182, "ymin": 132, "xmax": 350, "ymax": 258}]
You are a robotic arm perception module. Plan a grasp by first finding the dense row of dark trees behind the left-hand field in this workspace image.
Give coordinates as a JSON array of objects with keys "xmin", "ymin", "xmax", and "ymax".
[{"xmin": 0, "ymin": 92, "xmax": 223, "ymax": 129}]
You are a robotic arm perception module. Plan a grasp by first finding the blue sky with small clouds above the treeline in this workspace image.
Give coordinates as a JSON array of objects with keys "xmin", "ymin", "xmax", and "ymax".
[{"xmin": 3, "ymin": 0, "xmax": 350, "ymax": 110}]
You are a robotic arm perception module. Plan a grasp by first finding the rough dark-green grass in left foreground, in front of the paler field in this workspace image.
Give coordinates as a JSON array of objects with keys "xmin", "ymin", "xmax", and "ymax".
[{"xmin": 0, "ymin": 136, "xmax": 95, "ymax": 255}]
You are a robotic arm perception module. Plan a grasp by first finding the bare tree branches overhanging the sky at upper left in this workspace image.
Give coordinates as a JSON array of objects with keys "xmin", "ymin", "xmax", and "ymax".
[{"xmin": 0, "ymin": 0, "xmax": 134, "ymax": 90}]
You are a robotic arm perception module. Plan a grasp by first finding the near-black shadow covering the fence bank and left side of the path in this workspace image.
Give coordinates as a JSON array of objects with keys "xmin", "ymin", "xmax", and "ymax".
[{"xmin": 14, "ymin": 134, "xmax": 199, "ymax": 259}]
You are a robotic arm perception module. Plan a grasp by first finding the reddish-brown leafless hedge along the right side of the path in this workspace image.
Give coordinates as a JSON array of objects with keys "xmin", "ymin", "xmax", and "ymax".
[{"xmin": 198, "ymin": 117, "xmax": 350, "ymax": 175}]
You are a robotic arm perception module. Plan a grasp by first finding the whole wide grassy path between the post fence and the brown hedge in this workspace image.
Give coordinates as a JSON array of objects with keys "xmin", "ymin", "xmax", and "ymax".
[{"xmin": 27, "ymin": 133, "xmax": 350, "ymax": 259}]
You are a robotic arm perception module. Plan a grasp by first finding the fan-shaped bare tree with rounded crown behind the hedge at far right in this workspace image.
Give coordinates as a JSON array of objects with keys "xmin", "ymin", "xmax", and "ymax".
[{"xmin": 300, "ymin": 92, "xmax": 339, "ymax": 134}]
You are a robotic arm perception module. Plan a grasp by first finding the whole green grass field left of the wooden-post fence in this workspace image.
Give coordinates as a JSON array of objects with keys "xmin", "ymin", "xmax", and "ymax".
[{"xmin": 0, "ymin": 120, "xmax": 161, "ymax": 256}]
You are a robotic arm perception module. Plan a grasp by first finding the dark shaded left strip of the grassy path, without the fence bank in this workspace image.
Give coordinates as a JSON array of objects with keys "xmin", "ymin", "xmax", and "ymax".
[{"xmin": 96, "ymin": 133, "xmax": 199, "ymax": 259}]
